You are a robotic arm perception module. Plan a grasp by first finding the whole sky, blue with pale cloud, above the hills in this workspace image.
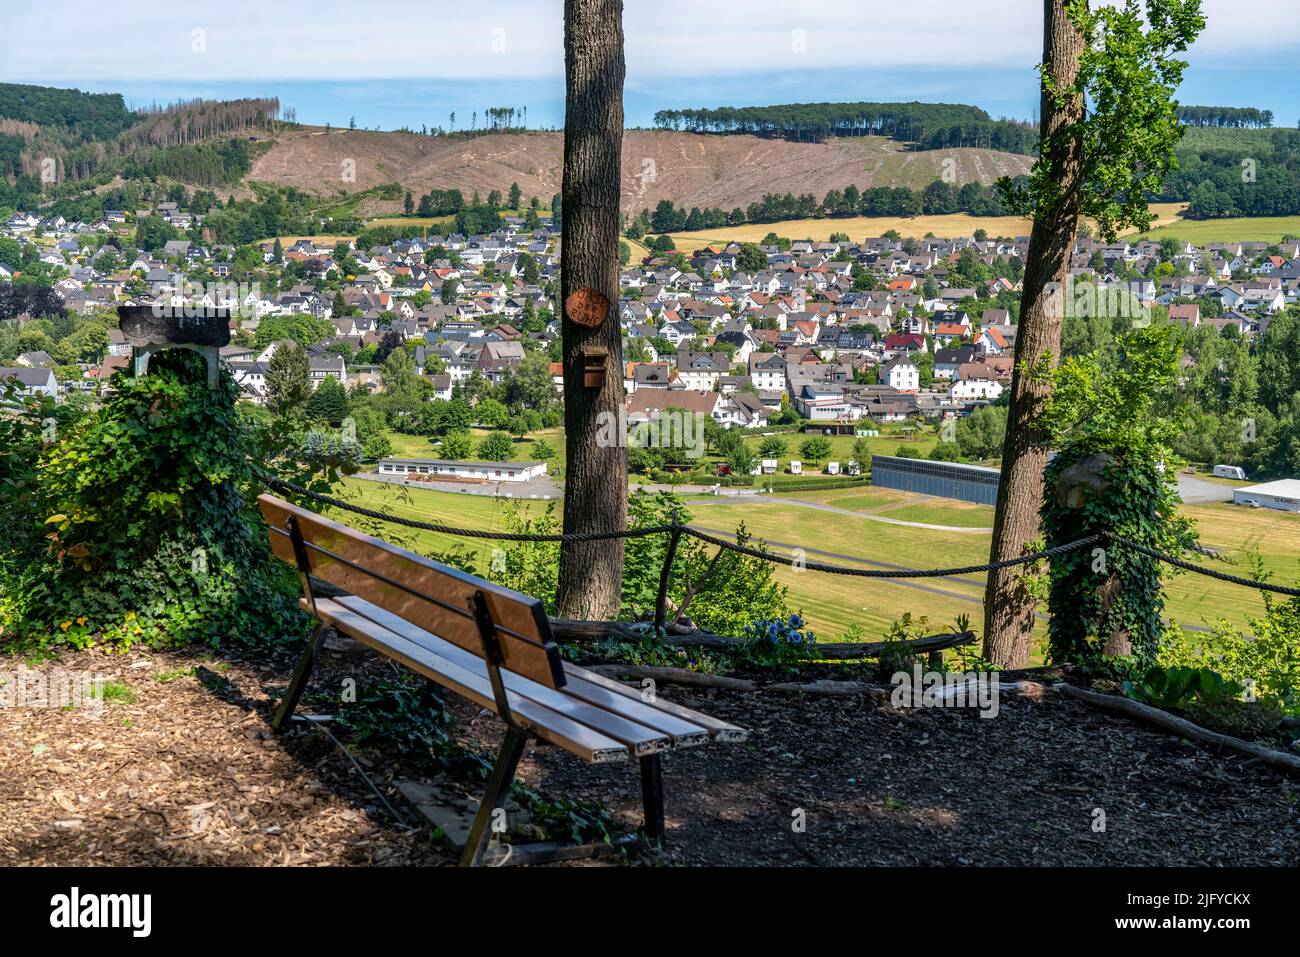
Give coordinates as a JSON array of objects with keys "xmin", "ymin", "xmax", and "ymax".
[{"xmin": 0, "ymin": 0, "xmax": 1300, "ymax": 129}]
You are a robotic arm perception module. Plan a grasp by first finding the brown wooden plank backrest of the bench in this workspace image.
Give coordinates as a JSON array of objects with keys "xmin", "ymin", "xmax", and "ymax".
[{"xmin": 257, "ymin": 495, "xmax": 564, "ymax": 688}]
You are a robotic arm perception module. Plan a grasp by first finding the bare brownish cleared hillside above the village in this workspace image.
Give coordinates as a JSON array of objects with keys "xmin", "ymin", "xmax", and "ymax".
[{"xmin": 248, "ymin": 129, "xmax": 1031, "ymax": 215}]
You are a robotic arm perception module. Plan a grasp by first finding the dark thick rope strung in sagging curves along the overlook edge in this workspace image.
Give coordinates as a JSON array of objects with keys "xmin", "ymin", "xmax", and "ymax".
[{"xmin": 254, "ymin": 467, "xmax": 1300, "ymax": 597}]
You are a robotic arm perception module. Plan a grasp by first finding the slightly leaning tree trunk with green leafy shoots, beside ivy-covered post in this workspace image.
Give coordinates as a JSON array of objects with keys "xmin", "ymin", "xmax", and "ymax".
[{"xmin": 984, "ymin": 0, "xmax": 1084, "ymax": 667}]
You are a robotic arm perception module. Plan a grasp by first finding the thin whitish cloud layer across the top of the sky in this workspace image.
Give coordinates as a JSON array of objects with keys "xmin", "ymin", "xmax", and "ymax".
[{"xmin": 0, "ymin": 0, "xmax": 1300, "ymax": 87}]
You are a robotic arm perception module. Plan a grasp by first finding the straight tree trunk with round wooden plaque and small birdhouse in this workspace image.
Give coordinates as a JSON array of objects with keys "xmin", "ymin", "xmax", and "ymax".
[{"xmin": 556, "ymin": 0, "xmax": 628, "ymax": 619}]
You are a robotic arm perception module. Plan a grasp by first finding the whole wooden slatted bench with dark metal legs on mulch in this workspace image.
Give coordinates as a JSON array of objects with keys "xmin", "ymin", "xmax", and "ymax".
[{"xmin": 257, "ymin": 495, "xmax": 749, "ymax": 865}]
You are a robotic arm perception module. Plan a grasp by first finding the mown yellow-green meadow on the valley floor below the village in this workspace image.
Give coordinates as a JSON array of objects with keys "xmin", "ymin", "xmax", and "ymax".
[{"xmin": 327, "ymin": 480, "xmax": 1300, "ymax": 650}]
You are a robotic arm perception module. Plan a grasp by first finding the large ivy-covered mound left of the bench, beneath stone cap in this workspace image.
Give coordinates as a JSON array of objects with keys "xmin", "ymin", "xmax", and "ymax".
[{"xmin": 0, "ymin": 351, "xmax": 307, "ymax": 648}]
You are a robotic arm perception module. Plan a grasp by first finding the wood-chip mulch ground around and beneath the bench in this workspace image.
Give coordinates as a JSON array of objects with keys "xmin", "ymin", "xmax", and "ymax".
[{"xmin": 0, "ymin": 650, "xmax": 1300, "ymax": 865}]
